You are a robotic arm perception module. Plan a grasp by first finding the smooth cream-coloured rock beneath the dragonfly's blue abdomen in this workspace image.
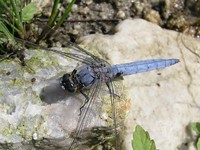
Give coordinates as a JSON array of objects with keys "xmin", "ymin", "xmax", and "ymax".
[{"xmin": 79, "ymin": 19, "xmax": 200, "ymax": 150}]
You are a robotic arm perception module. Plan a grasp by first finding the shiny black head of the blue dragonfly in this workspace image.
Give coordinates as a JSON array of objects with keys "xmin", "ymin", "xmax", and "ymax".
[{"xmin": 60, "ymin": 73, "xmax": 77, "ymax": 93}]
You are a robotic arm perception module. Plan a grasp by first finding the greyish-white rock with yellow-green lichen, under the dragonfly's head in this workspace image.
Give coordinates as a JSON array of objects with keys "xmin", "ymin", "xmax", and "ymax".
[{"xmin": 0, "ymin": 46, "xmax": 110, "ymax": 150}]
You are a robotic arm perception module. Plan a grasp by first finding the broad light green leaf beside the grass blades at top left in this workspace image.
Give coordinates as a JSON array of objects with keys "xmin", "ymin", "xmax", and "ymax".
[{"xmin": 22, "ymin": 2, "xmax": 36, "ymax": 22}]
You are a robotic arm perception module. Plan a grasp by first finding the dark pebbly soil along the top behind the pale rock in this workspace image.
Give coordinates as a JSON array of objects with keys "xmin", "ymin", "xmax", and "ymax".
[{"xmin": 35, "ymin": 0, "xmax": 200, "ymax": 46}]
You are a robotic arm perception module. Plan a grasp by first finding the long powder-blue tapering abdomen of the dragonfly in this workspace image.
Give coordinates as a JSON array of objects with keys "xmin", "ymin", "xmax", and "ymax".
[{"xmin": 110, "ymin": 59, "xmax": 179, "ymax": 77}]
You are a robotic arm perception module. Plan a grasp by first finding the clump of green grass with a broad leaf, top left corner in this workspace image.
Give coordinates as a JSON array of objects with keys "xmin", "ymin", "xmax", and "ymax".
[{"xmin": 0, "ymin": 0, "xmax": 36, "ymax": 55}]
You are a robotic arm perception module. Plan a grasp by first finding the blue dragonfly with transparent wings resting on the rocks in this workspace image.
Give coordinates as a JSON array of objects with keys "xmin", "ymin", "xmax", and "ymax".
[{"xmin": 0, "ymin": 39, "xmax": 179, "ymax": 150}]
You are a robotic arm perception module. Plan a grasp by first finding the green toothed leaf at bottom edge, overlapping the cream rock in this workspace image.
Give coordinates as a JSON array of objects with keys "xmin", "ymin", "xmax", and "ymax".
[{"xmin": 132, "ymin": 125, "xmax": 156, "ymax": 150}]
